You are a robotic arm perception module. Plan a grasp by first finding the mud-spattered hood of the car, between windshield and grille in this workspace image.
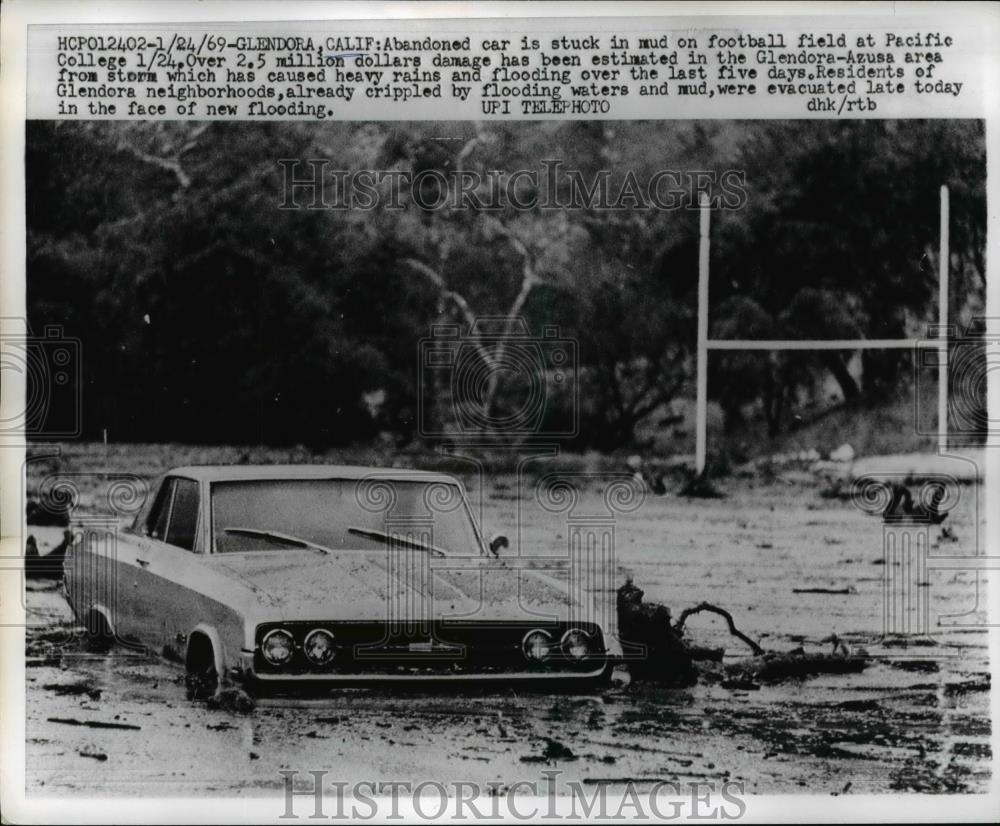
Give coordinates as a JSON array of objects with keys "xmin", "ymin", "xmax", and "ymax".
[{"xmin": 206, "ymin": 549, "xmax": 581, "ymax": 621}]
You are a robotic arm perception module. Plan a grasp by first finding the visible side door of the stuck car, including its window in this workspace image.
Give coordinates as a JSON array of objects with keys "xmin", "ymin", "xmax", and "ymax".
[{"xmin": 130, "ymin": 477, "xmax": 201, "ymax": 657}]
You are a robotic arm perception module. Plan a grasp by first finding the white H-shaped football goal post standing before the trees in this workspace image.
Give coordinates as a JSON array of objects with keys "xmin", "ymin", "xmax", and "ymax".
[{"xmin": 695, "ymin": 186, "xmax": 950, "ymax": 474}]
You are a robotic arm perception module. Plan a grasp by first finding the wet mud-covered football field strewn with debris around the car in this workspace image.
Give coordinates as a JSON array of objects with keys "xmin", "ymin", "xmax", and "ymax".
[{"xmin": 26, "ymin": 460, "xmax": 991, "ymax": 796}]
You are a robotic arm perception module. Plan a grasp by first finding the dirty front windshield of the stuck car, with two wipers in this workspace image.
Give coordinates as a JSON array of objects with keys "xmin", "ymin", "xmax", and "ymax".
[{"xmin": 212, "ymin": 477, "xmax": 480, "ymax": 556}]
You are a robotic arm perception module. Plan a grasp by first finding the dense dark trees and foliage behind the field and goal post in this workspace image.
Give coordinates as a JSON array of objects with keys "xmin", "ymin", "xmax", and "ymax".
[{"xmin": 26, "ymin": 121, "xmax": 986, "ymax": 450}]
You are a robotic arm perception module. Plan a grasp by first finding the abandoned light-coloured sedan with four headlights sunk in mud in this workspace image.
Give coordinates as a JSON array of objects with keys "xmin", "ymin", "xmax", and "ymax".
[{"xmin": 65, "ymin": 465, "xmax": 620, "ymax": 698}]
